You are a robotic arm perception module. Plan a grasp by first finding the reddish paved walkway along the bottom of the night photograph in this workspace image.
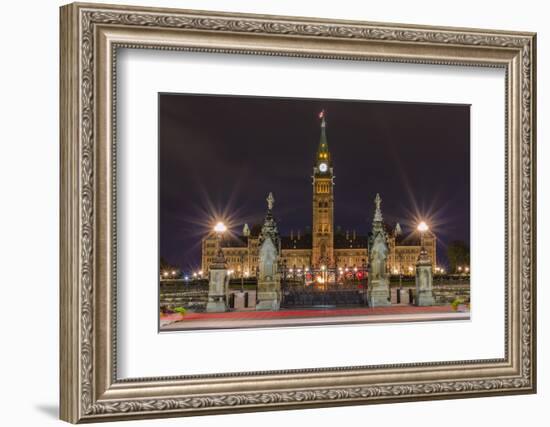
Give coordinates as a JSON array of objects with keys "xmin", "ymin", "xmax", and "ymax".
[{"xmin": 160, "ymin": 305, "xmax": 470, "ymax": 330}]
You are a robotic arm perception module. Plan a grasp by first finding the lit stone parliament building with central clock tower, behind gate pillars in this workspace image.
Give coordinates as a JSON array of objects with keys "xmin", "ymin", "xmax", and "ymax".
[{"xmin": 201, "ymin": 112, "xmax": 437, "ymax": 277}]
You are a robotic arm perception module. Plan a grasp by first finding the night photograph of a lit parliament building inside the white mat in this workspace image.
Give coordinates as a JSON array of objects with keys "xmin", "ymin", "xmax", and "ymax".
[{"xmin": 159, "ymin": 93, "xmax": 471, "ymax": 331}]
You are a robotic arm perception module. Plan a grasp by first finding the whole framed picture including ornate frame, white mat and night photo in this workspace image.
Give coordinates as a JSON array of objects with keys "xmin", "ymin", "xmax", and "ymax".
[{"xmin": 59, "ymin": 3, "xmax": 537, "ymax": 423}]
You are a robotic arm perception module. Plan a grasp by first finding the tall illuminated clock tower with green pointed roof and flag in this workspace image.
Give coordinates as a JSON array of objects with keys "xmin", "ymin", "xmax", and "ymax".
[{"xmin": 311, "ymin": 110, "xmax": 334, "ymax": 268}]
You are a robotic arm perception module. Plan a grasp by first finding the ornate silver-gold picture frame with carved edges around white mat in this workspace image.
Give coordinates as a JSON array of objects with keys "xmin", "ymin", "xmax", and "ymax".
[{"xmin": 60, "ymin": 4, "xmax": 536, "ymax": 423}]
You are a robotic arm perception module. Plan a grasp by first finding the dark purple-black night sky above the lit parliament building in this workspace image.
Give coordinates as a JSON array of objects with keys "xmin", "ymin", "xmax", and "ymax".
[{"xmin": 159, "ymin": 94, "xmax": 470, "ymax": 271}]
